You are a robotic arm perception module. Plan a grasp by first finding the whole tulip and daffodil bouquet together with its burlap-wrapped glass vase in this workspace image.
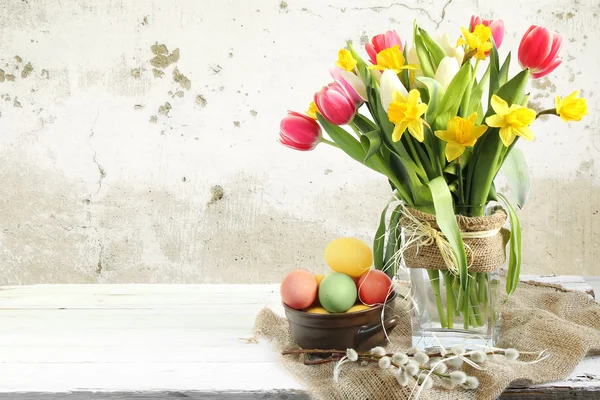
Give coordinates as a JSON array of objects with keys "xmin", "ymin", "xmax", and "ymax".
[{"xmin": 280, "ymin": 17, "xmax": 587, "ymax": 347}]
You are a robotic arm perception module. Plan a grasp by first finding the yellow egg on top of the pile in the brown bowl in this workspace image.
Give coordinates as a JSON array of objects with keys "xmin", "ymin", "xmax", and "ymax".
[{"xmin": 325, "ymin": 238, "xmax": 373, "ymax": 278}]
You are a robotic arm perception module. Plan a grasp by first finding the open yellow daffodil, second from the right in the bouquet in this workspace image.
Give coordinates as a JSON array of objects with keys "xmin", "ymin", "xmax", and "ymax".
[{"xmin": 485, "ymin": 95, "xmax": 536, "ymax": 147}]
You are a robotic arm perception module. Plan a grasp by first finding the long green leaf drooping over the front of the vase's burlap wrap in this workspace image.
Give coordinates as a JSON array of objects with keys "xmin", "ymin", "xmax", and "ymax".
[{"xmin": 429, "ymin": 176, "xmax": 469, "ymax": 292}]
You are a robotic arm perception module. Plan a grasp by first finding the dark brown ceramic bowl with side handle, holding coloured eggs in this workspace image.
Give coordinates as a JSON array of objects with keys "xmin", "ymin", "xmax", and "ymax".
[{"xmin": 283, "ymin": 293, "xmax": 399, "ymax": 351}]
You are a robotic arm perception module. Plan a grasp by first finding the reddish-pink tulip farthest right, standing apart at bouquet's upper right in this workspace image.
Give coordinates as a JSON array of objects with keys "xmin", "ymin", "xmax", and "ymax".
[{"xmin": 519, "ymin": 25, "xmax": 564, "ymax": 79}]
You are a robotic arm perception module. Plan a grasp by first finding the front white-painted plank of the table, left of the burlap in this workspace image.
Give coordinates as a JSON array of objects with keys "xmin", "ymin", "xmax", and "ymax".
[{"xmin": 0, "ymin": 361, "xmax": 302, "ymax": 392}]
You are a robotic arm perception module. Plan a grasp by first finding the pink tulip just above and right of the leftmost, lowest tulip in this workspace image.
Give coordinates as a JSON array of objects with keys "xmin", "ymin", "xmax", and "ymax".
[{"xmin": 314, "ymin": 82, "xmax": 356, "ymax": 125}]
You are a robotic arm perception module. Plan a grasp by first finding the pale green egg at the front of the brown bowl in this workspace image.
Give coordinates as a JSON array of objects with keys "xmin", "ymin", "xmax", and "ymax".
[{"xmin": 319, "ymin": 272, "xmax": 356, "ymax": 313}]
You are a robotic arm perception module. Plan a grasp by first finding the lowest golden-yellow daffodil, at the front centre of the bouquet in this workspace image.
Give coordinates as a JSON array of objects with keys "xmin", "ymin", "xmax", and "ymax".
[{"xmin": 435, "ymin": 113, "xmax": 487, "ymax": 162}]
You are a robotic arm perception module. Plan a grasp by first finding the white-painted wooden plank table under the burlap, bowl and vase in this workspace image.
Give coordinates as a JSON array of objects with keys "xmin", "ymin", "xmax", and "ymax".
[{"xmin": 0, "ymin": 277, "xmax": 600, "ymax": 400}]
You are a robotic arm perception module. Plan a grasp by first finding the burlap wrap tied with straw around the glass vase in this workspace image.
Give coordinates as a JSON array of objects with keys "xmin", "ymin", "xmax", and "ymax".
[{"xmin": 400, "ymin": 207, "xmax": 510, "ymax": 272}]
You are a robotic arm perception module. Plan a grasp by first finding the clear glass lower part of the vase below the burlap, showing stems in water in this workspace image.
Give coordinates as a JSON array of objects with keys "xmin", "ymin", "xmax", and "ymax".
[{"xmin": 409, "ymin": 268, "xmax": 500, "ymax": 350}]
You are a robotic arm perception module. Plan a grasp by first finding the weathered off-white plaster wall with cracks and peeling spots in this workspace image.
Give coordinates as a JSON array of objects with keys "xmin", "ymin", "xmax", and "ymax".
[{"xmin": 0, "ymin": 0, "xmax": 600, "ymax": 284}]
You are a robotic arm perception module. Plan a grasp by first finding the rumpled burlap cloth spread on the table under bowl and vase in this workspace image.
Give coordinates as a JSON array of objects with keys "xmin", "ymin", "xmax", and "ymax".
[{"xmin": 254, "ymin": 282, "xmax": 600, "ymax": 400}]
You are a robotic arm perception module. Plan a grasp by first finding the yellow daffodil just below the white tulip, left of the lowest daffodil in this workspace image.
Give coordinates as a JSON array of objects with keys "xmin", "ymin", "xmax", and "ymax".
[{"xmin": 388, "ymin": 89, "xmax": 427, "ymax": 142}]
